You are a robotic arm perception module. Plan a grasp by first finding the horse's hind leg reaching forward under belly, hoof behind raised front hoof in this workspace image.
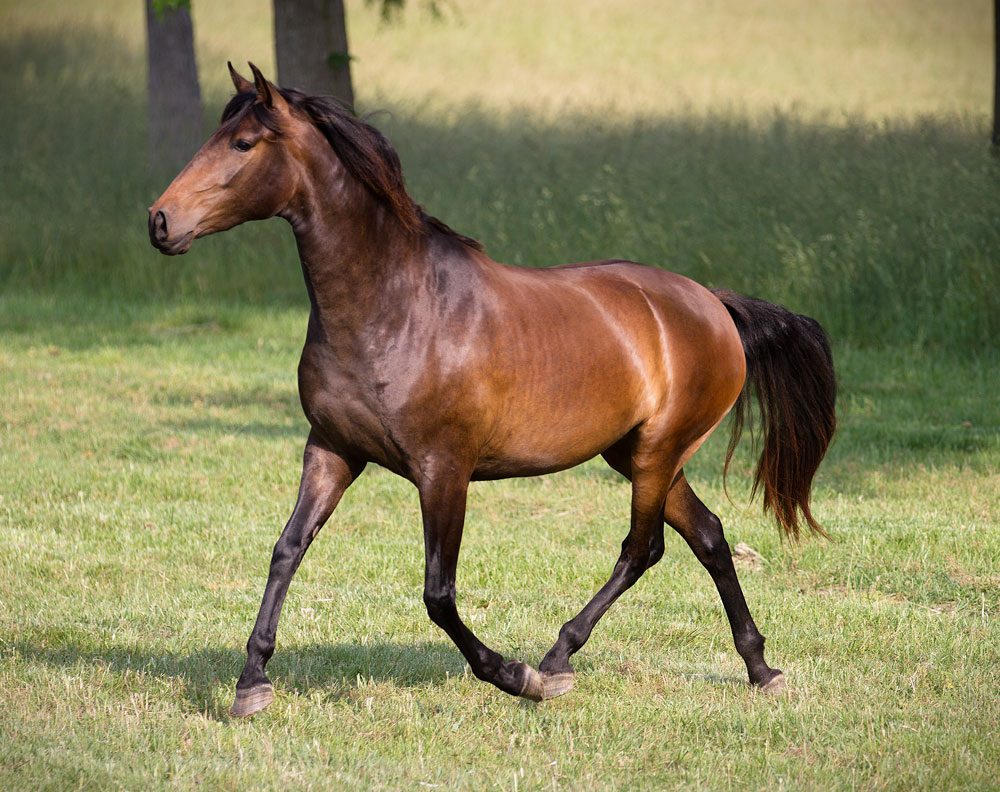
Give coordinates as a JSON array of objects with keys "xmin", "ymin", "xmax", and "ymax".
[{"xmin": 538, "ymin": 446, "xmax": 674, "ymax": 698}]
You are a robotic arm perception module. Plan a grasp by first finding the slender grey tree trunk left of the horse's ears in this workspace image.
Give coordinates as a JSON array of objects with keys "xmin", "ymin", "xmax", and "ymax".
[{"xmin": 146, "ymin": 0, "xmax": 203, "ymax": 171}]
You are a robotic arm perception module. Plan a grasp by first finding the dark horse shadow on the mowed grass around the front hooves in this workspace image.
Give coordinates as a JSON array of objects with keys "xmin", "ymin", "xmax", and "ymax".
[{"xmin": 4, "ymin": 638, "xmax": 466, "ymax": 720}]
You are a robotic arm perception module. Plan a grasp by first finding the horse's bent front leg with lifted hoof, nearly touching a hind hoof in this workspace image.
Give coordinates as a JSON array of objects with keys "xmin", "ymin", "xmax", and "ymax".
[{"xmin": 418, "ymin": 470, "xmax": 543, "ymax": 701}]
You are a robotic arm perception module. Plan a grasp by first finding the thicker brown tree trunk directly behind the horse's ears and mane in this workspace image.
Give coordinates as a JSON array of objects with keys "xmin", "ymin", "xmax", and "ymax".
[{"xmin": 274, "ymin": 0, "xmax": 354, "ymax": 108}]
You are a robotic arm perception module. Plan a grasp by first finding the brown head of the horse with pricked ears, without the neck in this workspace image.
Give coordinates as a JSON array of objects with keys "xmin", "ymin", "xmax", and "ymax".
[{"xmin": 149, "ymin": 64, "xmax": 309, "ymax": 255}]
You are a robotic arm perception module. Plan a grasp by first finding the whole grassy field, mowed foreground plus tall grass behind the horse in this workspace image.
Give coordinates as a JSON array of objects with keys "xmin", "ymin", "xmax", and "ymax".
[{"xmin": 0, "ymin": 0, "xmax": 1000, "ymax": 790}]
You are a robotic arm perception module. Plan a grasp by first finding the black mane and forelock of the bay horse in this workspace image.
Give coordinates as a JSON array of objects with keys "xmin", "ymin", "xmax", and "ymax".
[{"xmin": 222, "ymin": 88, "xmax": 483, "ymax": 250}]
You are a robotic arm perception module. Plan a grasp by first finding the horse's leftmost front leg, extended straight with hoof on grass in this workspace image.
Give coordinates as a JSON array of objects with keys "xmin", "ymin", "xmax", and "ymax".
[{"xmin": 232, "ymin": 435, "xmax": 364, "ymax": 717}]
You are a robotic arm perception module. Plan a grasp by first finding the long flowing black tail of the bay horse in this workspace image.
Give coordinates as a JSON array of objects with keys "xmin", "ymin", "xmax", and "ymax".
[{"xmin": 713, "ymin": 289, "xmax": 837, "ymax": 539}]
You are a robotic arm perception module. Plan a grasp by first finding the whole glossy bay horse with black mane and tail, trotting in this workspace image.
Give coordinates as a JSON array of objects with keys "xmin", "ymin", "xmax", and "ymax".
[{"xmin": 149, "ymin": 64, "xmax": 836, "ymax": 717}]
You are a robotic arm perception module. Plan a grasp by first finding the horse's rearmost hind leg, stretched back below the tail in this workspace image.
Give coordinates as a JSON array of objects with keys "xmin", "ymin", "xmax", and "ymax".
[{"xmin": 664, "ymin": 473, "xmax": 785, "ymax": 690}]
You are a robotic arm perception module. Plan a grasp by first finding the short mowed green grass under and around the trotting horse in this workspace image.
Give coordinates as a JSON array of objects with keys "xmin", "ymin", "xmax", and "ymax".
[{"xmin": 0, "ymin": 300, "xmax": 1000, "ymax": 789}]
